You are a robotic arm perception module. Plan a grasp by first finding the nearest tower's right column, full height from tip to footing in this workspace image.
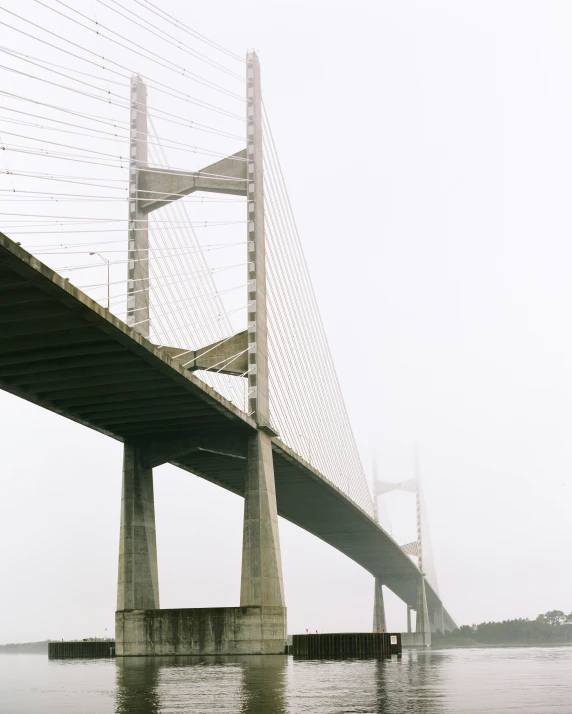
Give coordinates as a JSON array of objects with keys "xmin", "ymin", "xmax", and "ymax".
[{"xmin": 240, "ymin": 52, "xmax": 284, "ymax": 607}]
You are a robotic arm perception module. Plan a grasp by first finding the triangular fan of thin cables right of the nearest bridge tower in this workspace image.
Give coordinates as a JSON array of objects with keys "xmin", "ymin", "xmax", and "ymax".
[{"xmin": 263, "ymin": 103, "xmax": 373, "ymax": 515}]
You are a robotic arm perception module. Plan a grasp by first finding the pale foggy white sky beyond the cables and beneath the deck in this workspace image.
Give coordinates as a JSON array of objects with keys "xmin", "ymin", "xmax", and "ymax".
[{"xmin": 0, "ymin": 0, "xmax": 572, "ymax": 642}]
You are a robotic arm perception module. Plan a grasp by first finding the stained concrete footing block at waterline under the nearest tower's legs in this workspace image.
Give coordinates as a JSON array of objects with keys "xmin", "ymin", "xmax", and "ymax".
[{"xmin": 115, "ymin": 606, "xmax": 286, "ymax": 657}]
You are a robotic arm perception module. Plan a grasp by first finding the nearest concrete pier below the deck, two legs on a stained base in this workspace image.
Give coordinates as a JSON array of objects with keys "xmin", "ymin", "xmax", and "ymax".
[{"xmin": 115, "ymin": 429, "xmax": 286, "ymax": 657}]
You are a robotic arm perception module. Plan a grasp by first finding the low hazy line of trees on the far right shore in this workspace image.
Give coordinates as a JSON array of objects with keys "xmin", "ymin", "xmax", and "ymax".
[{"xmin": 431, "ymin": 610, "xmax": 572, "ymax": 649}]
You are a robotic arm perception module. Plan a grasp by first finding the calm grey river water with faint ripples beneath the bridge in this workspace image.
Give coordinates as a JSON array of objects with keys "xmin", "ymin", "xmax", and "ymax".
[{"xmin": 0, "ymin": 647, "xmax": 572, "ymax": 714}]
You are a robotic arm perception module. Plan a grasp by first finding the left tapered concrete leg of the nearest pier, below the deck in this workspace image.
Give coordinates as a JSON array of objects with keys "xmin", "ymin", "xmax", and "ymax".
[{"xmin": 117, "ymin": 441, "xmax": 159, "ymax": 610}]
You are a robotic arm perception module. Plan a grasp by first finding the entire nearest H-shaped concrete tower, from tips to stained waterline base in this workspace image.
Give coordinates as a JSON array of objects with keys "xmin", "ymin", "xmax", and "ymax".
[{"xmin": 116, "ymin": 52, "xmax": 286, "ymax": 655}]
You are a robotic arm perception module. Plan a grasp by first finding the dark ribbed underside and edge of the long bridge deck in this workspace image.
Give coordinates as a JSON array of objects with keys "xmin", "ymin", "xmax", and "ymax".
[{"xmin": 0, "ymin": 234, "xmax": 454, "ymax": 628}]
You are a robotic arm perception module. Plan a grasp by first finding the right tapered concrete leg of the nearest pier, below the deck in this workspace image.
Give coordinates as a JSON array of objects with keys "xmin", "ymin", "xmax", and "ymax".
[{"xmin": 240, "ymin": 431, "xmax": 284, "ymax": 607}]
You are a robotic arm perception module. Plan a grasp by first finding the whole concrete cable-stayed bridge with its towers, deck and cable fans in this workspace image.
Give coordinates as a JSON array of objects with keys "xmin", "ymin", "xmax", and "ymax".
[{"xmin": 0, "ymin": 0, "xmax": 454, "ymax": 654}]
